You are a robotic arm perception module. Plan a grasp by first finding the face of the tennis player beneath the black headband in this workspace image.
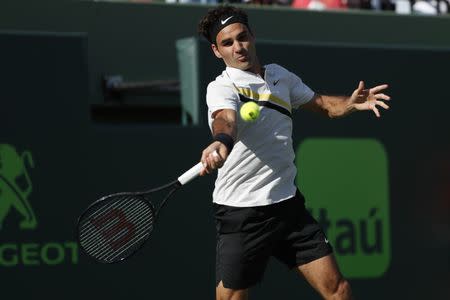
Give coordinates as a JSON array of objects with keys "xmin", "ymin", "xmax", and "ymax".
[{"xmin": 212, "ymin": 23, "xmax": 258, "ymax": 71}]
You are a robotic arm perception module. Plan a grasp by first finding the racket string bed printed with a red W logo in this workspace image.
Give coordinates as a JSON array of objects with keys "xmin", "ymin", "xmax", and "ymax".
[{"xmin": 79, "ymin": 195, "xmax": 154, "ymax": 263}]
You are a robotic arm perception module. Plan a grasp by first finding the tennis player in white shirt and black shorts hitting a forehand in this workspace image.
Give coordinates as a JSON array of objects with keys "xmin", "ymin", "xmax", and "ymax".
[{"xmin": 199, "ymin": 6, "xmax": 390, "ymax": 300}]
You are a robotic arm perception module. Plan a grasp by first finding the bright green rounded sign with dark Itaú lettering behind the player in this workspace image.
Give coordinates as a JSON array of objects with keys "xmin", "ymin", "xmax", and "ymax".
[{"xmin": 297, "ymin": 138, "xmax": 391, "ymax": 278}]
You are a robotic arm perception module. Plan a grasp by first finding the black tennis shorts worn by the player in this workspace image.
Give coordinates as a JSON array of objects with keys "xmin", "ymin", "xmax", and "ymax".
[{"xmin": 214, "ymin": 193, "xmax": 332, "ymax": 290}]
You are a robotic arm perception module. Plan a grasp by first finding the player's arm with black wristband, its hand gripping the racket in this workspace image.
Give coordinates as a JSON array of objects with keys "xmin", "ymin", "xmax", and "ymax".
[{"xmin": 200, "ymin": 109, "xmax": 237, "ymax": 176}]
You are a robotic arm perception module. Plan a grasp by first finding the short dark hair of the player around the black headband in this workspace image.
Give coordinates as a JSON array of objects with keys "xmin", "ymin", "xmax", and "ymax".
[{"xmin": 198, "ymin": 5, "xmax": 251, "ymax": 44}]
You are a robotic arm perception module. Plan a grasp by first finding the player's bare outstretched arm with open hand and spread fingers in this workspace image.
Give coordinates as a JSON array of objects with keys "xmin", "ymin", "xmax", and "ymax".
[{"xmin": 302, "ymin": 81, "xmax": 391, "ymax": 118}]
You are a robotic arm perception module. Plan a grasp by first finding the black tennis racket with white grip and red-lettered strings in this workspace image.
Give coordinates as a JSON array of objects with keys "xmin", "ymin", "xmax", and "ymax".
[{"xmin": 77, "ymin": 158, "xmax": 203, "ymax": 264}]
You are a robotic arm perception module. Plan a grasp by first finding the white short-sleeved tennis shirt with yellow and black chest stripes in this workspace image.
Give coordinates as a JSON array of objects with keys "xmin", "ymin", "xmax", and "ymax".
[{"xmin": 206, "ymin": 64, "xmax": 314, "ymax": 207}]
